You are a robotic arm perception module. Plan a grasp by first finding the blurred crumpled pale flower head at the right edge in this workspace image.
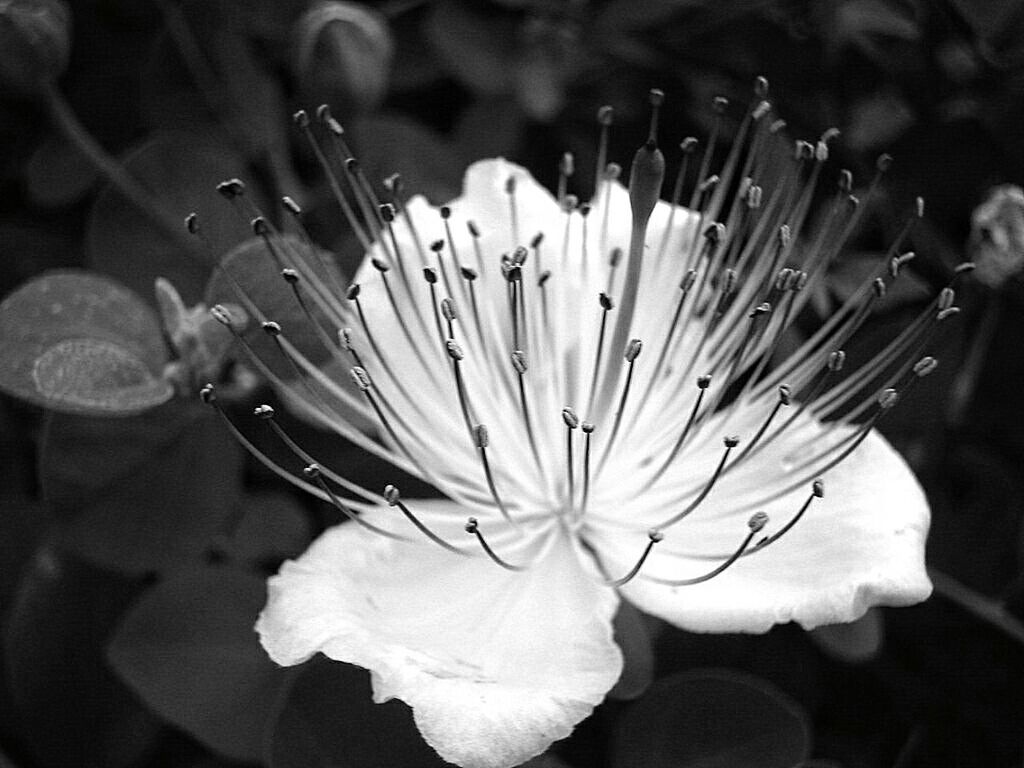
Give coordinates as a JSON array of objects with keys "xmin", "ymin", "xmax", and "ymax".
[{"xmin": 969, "ymin": 184, "xmax": 1024, "ymax": 288}]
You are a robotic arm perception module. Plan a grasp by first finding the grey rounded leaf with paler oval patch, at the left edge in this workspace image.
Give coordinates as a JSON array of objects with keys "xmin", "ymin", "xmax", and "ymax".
[{"xmin": 0, "ymin": 270, "xmax": 174, "ymax": 416}]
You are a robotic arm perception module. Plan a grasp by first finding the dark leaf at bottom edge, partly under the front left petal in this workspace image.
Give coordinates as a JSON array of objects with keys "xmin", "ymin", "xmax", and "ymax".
[{"xmin": 266, "ymin": 656, "xmax": 447, "ymax": 768}]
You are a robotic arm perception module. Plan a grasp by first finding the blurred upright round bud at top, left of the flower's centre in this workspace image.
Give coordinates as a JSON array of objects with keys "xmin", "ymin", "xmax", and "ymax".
[{"xmin": 293, "ymin": 2, "xmax": 394, "ymax": 118}]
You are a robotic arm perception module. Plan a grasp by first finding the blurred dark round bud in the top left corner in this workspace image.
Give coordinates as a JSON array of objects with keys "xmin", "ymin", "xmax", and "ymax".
[{"xmin": 0, "ymin": 0, "xmax": 71, "ymax": 92}]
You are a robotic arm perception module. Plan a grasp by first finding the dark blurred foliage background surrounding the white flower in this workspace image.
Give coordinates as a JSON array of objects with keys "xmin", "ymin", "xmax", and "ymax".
[{"xmin": 0, "ymin": 0, "xmax": 1024, "ymax": 768}]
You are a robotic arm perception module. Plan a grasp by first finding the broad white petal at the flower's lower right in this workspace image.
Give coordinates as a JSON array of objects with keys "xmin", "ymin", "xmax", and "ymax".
[{"xmin": 596, "ymin": 433, "xmax": 931, "ymax": 632}]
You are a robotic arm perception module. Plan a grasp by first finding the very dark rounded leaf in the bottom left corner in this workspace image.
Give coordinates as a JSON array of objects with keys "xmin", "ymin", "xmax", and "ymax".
[{"xmin": 3, "ymin": 545, "xmax": 159, "ymax": 768}]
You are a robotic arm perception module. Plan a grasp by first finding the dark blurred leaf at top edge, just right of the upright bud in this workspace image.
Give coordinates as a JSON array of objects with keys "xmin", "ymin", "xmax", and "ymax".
[{"xmin": 424, "ymin": 0, "xmax": 517, "ymax": 96}]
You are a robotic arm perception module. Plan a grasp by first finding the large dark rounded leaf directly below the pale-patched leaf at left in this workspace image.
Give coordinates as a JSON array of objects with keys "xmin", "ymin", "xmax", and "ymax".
[{"xmin": 40, "ymin": 400, "xmax": 242, "ymax": 573}]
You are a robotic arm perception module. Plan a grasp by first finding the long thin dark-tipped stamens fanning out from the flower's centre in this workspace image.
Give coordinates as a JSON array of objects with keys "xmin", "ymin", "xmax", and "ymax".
[{"xmin": 187, "ymin": 80, "xmax": 970, "ymax": 587}]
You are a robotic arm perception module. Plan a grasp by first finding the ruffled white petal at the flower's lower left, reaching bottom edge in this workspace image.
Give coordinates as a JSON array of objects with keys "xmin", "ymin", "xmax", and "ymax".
[{"xmin": 257, "ymin": 502, "xmax": 622, "ymax": 768}]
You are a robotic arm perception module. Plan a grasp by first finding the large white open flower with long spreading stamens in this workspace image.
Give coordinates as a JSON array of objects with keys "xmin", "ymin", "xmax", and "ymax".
[{"xmin": 206, "ymin": 83, "xmax": 956, "ymax": 768}]
